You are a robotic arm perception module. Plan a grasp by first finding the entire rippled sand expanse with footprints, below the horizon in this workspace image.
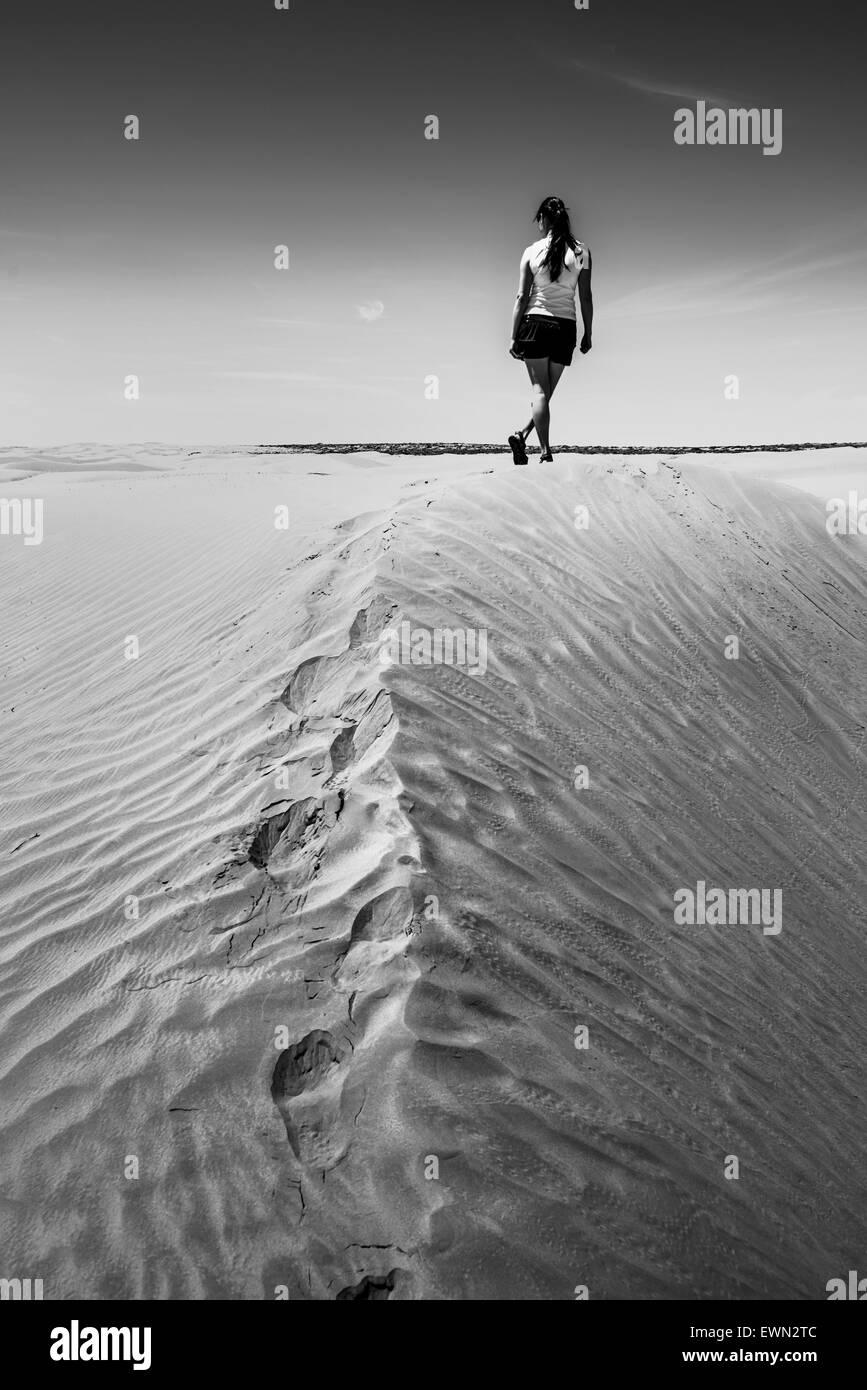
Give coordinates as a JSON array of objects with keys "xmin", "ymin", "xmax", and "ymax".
[{"xmin": 0, "ymin": 448, "xmax": 867, "ymax": 1300}]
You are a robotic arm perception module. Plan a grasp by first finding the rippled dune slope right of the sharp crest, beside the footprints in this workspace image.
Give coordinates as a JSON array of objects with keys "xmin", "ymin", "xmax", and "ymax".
[{"xmin": 265, "ymin": 466, "xmax": 867, "ymax": 1298}]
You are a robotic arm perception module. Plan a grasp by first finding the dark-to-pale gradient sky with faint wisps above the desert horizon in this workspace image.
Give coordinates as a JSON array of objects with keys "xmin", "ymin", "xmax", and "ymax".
[{"xmin": 0, "ymin": 0, "xmax": 867, "ymax": 446}]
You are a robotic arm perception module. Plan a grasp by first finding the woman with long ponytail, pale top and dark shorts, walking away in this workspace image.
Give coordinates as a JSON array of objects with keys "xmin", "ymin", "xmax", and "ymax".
[{"xmin": 509, "ymin": 197, "xmax": 593, "ymax": 463}]
